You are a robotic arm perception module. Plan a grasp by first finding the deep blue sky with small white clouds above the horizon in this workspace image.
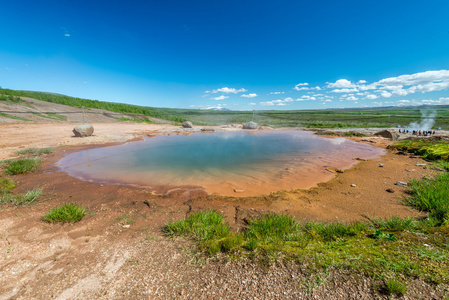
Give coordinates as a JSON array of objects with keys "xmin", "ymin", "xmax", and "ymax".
[{"xmin": 0, "ymin": 0, "xmax": 449, "ymax": 110}]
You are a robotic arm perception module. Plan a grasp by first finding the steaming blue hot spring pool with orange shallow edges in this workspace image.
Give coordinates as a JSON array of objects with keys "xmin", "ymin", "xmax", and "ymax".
[{"xmin": 56, "ymin": 130, "xmax": 383, "ymax": 196}]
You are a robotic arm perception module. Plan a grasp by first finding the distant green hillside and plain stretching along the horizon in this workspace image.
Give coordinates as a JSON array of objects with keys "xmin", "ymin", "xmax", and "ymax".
[{"xmin": 0, "ymin": 88, "xmax": 449, "ymax": 129}]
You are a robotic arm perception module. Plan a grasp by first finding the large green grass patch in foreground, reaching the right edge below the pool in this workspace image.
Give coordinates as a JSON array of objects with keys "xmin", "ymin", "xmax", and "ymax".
[{"xmin": 164, "ymin": 211, "xmax": 449, "ymax": 283}]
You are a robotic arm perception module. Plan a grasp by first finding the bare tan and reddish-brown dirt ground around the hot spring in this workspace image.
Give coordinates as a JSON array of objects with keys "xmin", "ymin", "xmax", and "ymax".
[{"xmin": 0, "ymin": 123, "xmax": 441, "ymax": 299}]
